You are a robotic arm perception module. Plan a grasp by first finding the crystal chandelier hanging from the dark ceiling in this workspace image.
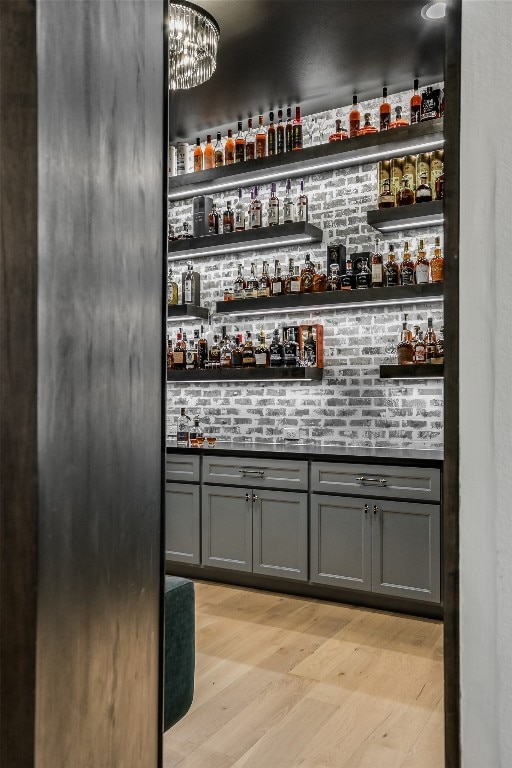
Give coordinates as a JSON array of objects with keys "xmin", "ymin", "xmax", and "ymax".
[{"xmin": 169, "ymin": 0, "xmax": 220, "ymax": 91}]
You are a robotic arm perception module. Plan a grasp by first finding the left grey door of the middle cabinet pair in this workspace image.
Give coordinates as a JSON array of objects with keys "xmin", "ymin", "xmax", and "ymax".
[{"xmin": 202, "ymin": 485, "xmax": 252, "ymax": 571}]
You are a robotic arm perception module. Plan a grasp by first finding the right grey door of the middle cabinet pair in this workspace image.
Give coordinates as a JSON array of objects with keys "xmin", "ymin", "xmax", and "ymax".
[{"xmin": 253, "ymin": 489, "xmax": 308, "ymax": 581}]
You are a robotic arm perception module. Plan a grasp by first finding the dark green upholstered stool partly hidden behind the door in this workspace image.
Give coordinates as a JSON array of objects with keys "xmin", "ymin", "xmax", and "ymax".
[{"xmin": 164, "ymin": 576, "xmax": 195, "ymax": 731}]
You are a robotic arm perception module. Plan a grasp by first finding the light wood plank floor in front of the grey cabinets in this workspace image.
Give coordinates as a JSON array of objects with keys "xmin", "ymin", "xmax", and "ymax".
[{"xmin": 164, "ymin": 583, "xmax": 444, "ymax": 768}]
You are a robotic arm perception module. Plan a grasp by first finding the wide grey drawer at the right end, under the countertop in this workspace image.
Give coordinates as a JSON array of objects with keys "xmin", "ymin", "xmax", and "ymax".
[{"xmin": 311, "ymin": 461, "xmax": 441, "ymax": 501}]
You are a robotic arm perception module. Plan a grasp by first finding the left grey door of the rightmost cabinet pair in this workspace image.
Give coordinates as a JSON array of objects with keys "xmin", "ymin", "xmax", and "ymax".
[{"xmin": 310, "ymin": 493, "xmax": 372, "ymax": 591}]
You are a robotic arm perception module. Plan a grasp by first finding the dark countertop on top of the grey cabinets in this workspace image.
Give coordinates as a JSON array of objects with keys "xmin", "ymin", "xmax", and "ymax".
[{"xmin": 167, "ymin": 441, "xmax": 443, "ymax": 467}]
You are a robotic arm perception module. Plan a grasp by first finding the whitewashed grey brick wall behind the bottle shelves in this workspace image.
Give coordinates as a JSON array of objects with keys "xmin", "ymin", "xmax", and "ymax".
[{"xmin": 167, "ymin": 85, "xmax": 443, "ymax": 448}]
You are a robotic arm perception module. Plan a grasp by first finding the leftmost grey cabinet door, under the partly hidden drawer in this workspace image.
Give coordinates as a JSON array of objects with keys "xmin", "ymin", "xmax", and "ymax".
[{"xmin": 165, "ymin": 483, "xmax": 201, "ymax": 565}]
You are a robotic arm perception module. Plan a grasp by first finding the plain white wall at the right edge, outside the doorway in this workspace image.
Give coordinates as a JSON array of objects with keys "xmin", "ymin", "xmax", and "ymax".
[{"xmin": 460, "ymin": 0, "xmax": 512, "ymax": 768}]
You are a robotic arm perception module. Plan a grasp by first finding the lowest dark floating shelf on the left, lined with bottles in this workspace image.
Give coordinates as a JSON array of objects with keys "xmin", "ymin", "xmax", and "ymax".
[{"xmin": 167, "ymin": 368, "xmax": 323, "ymax": 384}]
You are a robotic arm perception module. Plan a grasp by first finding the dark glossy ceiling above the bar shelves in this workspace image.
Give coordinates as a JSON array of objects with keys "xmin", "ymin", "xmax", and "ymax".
[{"xmin": 169, "ymin": 0, "xmax": 444, "ymax": 142}]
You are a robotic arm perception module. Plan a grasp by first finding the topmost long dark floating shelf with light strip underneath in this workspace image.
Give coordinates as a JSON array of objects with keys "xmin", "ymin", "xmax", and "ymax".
[{"xmin": 168, "ymin": 118, "xmax": 444, "ymax": 200}]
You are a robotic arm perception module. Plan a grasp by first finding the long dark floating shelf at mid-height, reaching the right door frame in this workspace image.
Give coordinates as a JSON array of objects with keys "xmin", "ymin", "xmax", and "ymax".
[{"xmin": 216, "ymin": 283, "xmax": 443, "ymax": 315}]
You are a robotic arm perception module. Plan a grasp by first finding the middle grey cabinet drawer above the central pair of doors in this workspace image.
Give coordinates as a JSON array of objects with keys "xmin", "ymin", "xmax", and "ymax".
[{"xmin": 203, "ymin": 456, "xmax": 308, "ymax": 491}]
